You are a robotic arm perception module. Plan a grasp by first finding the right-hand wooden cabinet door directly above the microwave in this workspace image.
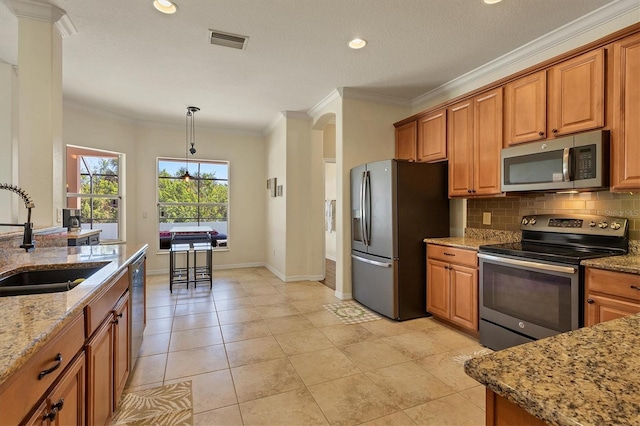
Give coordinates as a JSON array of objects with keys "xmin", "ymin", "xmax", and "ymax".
[{"xmin": 547, "ymin": 49, "xmax": 605, "ymax": 137}]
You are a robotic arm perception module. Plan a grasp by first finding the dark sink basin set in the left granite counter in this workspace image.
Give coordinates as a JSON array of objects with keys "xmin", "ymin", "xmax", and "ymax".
[{"xmin": 0, "ymin": 263, "xmax": 106, "ymax": 297}]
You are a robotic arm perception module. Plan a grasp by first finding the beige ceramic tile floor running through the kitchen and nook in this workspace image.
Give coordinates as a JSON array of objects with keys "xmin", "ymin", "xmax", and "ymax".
[{"xmin": 122, "ymin": 268, "xmax": 485, "ymax": 426}]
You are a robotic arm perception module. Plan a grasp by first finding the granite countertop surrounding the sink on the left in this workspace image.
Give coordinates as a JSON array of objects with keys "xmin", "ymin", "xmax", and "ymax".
[{"xmin": 0, "ymin": 244, "xmax": 148, "ymax": 384}]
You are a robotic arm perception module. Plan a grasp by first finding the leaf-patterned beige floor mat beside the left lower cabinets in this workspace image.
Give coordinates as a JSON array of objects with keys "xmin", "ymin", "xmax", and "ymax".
[{"xmin": 111, "ymin": 381, "xmax": 193, "ymax": 425}]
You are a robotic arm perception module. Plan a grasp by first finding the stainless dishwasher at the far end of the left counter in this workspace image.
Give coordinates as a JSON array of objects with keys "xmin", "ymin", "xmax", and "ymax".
[{"xmin": 129, "ymin": 254, "xmax": 147, "ymax": 377}]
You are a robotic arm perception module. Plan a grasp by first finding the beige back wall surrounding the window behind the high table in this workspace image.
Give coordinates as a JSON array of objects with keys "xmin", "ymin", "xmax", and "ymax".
[{"xmin": 64, "ymin": 106, "xmax": 266, "ymax": 274}]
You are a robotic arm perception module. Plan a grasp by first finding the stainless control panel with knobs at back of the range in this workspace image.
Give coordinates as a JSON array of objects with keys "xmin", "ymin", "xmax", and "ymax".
[{"xmin": 520, "ymin": 214, "xmax": 629, "ymax": 237}]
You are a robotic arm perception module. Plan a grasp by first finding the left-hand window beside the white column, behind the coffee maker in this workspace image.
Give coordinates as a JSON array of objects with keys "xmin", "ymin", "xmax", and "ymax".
[{"xmin": 66, "ymin": 145, "xmax": 124, "ymax": 242}]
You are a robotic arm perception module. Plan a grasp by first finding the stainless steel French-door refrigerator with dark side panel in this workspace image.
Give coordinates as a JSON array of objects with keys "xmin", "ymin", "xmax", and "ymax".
[{"xmin": 351, "ymin": 160, "xmax": 449, "ymax": 320}]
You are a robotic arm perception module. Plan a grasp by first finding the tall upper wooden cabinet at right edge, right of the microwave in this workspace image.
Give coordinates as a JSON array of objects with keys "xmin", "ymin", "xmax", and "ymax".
[{"xmin": 610, "ymin": 34, "xmax": 640, "ymax": 191}]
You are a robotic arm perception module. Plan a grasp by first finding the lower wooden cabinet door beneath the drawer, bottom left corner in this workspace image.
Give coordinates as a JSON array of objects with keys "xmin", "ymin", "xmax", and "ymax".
[{"xmin": 25, "ymin": 352, "xmax": 85, "ymax": 426}]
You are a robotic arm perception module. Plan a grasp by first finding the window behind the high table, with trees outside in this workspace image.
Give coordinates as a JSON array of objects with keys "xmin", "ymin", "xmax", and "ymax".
[{"xmin": 158, "ymin": 158, "xmax": 229, "ymax": 250}]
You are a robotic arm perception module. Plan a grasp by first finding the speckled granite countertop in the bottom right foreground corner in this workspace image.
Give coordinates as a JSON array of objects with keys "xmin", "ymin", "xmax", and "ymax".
[{"xmin": 465, "ymin": 314, "xmax": 640, "ymax": 425}]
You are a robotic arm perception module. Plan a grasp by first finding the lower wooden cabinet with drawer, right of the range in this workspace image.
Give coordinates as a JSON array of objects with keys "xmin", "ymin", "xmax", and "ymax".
[{"xmin": 584, "ymin": 267, "xmax": 640, "ymax": 327}]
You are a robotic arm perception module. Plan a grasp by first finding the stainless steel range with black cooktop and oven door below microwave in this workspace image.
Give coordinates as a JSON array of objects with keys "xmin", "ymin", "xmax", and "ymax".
[{"xmin": 478, "ymin": 214, "xmax": 629, "ymax": 350}]
